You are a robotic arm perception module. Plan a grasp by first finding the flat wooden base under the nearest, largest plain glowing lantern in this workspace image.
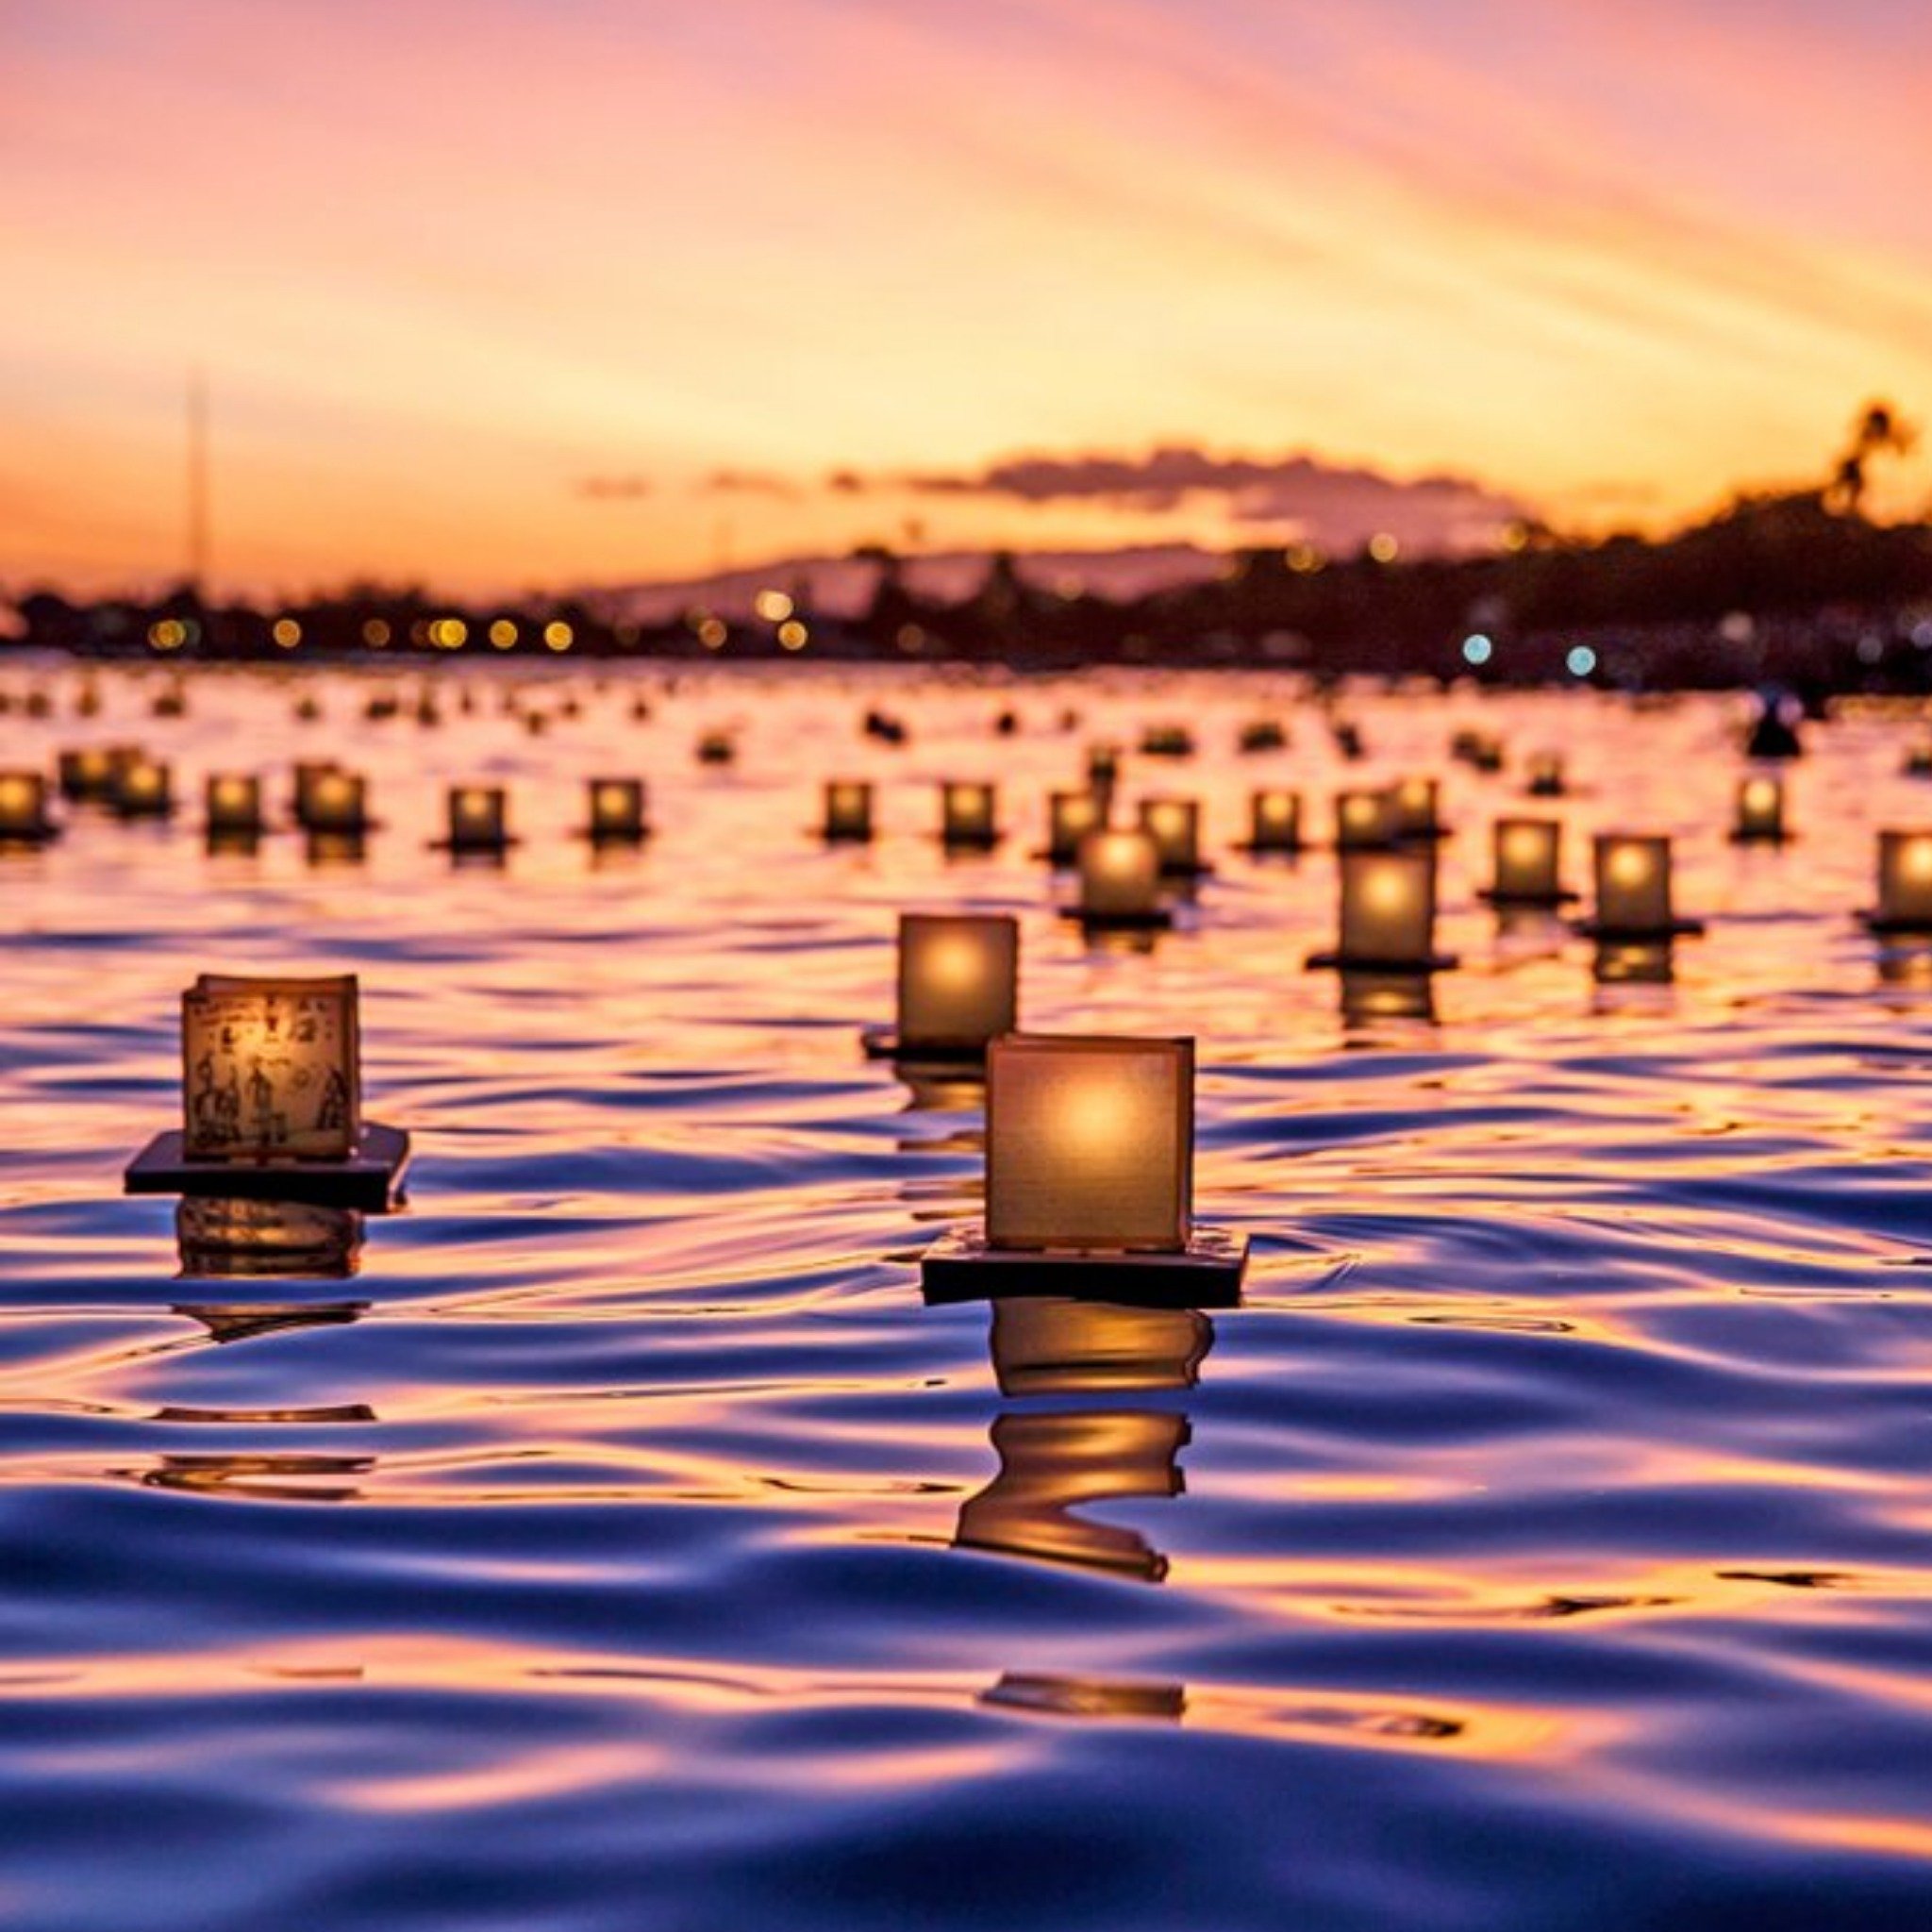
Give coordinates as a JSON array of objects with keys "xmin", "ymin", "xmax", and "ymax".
[{"xmin": 920, "ymin": 1224, "xmax": 1248, "ymax": 1307}]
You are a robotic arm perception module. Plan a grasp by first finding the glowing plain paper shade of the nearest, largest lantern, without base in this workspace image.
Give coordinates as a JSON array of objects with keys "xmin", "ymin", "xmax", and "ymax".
[{"xmin": 985, "ymin": 1034, "xmax": 1194, "ymax": 1252}]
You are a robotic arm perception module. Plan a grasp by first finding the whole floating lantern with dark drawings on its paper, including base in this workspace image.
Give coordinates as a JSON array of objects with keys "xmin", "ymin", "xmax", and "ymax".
[{"xmin": 125, "ymin": 974, "xmax": 409, "ymax": 1208}]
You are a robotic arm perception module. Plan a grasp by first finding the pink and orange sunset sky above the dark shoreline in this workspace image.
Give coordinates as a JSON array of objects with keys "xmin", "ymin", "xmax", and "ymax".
[{"xmin": 0, "ymin": 0, "xmax": 1932, "ymax": 591}]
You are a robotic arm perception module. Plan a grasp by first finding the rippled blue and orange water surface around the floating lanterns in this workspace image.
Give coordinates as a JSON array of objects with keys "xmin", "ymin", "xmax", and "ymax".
[{"xmin": 0, "ymin": 675, "xmax": 1932, "ymax": 1932}]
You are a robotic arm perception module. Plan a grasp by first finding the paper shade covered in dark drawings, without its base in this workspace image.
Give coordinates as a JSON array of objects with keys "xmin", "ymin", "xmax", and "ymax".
[{"xmin": 182, "ymin": 974, "xmax": 361, "ymax": 1161}]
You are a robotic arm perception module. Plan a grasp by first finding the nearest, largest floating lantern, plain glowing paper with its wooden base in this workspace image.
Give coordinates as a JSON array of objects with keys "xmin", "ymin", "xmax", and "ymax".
[{"xmin": 924, "ymin": 1034, "xmax": 1246, "ymax": 1306}]
